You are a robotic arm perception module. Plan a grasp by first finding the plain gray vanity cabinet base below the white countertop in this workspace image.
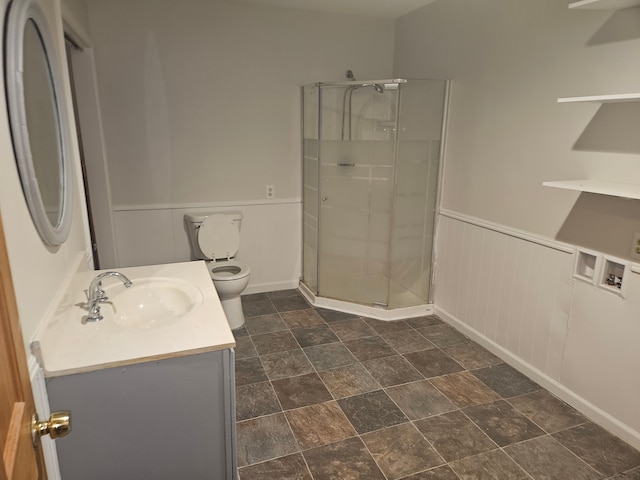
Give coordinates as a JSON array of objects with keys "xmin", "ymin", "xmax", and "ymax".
[{"xmin": 47, "ymin": 349, "xmax": 236, "ymax": 480}]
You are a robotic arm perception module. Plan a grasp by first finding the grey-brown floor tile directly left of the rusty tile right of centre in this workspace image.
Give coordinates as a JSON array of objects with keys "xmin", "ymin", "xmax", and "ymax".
[{"xmin": 385, "ymin": 380, "xmax": 456, "ymax": 420}]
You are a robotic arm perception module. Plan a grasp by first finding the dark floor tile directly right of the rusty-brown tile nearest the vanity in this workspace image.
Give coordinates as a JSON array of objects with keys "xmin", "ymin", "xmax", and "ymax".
[{"xmin": 338, "ymin": 390, "xmax": 408, "ymax": 434}]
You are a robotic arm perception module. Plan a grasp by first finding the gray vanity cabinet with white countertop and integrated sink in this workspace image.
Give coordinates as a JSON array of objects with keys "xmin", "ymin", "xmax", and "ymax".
[{"xmin": 34, "ymin": 262, "xmax": 236, "ymax": 480}]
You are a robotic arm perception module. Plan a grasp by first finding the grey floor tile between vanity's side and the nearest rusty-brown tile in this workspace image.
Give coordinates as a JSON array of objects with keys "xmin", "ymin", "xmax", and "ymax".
[{"xmin": 236, "ymin": 413, "xmax": 300, "ymax": 467}]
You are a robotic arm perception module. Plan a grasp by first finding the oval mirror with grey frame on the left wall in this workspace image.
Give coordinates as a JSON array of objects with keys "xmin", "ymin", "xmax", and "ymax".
[{"xmin": 5, "ymin": 0, "xmax": 72, "ymax": 247}]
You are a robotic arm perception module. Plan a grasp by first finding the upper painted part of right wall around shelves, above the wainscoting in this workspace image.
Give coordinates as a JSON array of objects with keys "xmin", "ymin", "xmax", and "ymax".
[{"xmin": 394, "ymin": 0, "xmax": 640, "ymax": 256}]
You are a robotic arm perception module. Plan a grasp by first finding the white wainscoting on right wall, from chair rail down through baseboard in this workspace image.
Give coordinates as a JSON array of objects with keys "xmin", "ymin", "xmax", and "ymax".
[{"xmin": 434, "ymin": 211, "xmax": 640, "ymax": 448}]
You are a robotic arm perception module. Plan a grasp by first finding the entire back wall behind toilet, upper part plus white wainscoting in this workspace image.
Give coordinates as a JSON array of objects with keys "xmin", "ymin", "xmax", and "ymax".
[{"xmin": 88, "ymin": 0, "xmax": 394, "ymax": 284}]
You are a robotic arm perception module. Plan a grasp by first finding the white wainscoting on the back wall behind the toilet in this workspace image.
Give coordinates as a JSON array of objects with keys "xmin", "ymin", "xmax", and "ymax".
[{"xmin": 113, "ymin": 199, "xmax": 302, "ymax": 293}]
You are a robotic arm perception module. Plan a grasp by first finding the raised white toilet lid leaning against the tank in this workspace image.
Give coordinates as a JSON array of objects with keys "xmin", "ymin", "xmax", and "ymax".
[{"xmin": 198, "ymin": 215, "xmax": 240, "ymax": 260}]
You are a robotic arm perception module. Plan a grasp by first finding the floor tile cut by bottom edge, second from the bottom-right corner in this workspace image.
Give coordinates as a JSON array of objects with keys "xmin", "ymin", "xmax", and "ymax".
[{"xmin": 504, "ymin": 435, "xmax": 603, "ymax": 480}]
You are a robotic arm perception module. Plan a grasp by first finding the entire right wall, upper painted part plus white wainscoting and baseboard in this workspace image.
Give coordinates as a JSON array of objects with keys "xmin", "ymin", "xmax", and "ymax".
[{"xmin": 394, "ymin": 0, "xmax": 640, "ymax": 447}]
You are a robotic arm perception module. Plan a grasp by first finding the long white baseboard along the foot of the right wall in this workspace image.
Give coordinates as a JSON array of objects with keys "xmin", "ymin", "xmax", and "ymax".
[{"xmin": 435, "ymin": 306, "xmax": 640, "ymax": 449}]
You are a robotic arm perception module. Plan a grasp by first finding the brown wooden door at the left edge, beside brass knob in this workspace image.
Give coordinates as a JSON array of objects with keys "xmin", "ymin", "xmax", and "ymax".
[{"xmin": 0, "ymin": 217, "xmax": 47, "ymax": 480}]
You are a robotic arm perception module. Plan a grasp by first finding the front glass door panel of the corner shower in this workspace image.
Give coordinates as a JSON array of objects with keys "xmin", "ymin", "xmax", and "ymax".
[{"xmin": 317, "ymin": 86, "xmax": 398, "ymax": 307}]
